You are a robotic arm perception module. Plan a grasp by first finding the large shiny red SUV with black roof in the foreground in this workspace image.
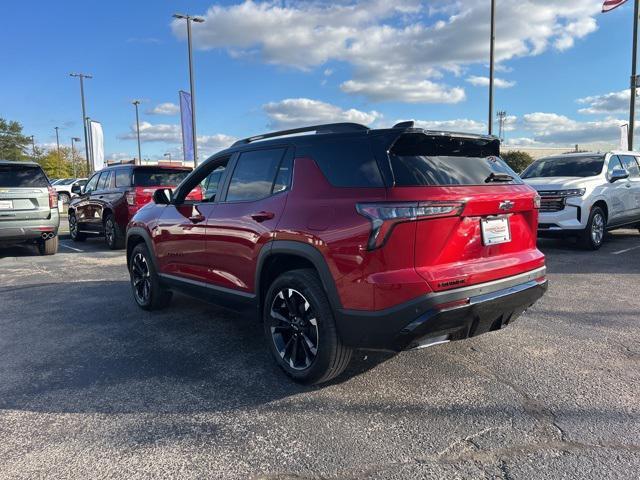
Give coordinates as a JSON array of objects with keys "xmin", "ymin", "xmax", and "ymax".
[{"xmin": 127, "ymin": 122, "xmax": 547, "ymax": 383}]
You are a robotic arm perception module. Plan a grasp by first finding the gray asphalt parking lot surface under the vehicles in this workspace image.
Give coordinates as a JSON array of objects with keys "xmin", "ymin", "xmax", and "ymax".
[{"xmin": 0, "ymin": 223, "xmax": 640, "ymax": 479}]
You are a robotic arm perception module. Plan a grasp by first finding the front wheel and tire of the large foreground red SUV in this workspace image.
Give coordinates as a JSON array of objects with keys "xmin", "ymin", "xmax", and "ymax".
[{"xmin": 129, "ymin": 243, "xmax": 173, "ymax": 310}]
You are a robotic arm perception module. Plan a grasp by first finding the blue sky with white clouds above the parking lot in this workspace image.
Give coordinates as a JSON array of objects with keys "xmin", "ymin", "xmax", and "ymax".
[{"xmin": 0, "ymin": 0, "xmax": 633, "ymax": 160}]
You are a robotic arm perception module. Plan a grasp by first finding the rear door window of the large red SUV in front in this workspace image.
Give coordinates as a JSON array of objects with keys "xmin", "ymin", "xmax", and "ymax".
[{"xmin": 226, "ymin": 148, "xmax": 286, "ymax": 202}]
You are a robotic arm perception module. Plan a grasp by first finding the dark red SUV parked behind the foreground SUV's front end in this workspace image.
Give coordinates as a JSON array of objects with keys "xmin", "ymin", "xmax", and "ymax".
[{"xmin": 69, "ymin": 165, "xmax": 191, "ymax": 250}]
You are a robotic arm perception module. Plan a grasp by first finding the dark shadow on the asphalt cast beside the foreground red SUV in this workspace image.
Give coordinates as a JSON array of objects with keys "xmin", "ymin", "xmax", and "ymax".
[{"xmin": 0, "ymin": 281, "xmax": 389, "ymax": 413}]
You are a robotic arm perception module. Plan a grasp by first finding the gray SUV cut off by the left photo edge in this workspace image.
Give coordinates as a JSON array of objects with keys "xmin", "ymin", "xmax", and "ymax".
[{"xmin": 0, "ymin": 160, "xmax": 60, "ymax": 255}]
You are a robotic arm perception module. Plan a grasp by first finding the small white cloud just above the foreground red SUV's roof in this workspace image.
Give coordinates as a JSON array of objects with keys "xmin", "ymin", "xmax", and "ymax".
[{"xmin": 262, "ymin": 98, "xmax": 382, "ymax": 129}]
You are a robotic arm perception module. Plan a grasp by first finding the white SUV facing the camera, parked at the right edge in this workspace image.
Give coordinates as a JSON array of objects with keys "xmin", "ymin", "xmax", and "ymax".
[{"xmin": 521, "ymin": 151, "xmax": 640, "ymax": 250}]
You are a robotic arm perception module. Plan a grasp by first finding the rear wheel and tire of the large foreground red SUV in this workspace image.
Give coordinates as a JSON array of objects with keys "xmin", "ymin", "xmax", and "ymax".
[{"xmin": 262, "ymin": 269, "xmax": 352, "ymax": 385}]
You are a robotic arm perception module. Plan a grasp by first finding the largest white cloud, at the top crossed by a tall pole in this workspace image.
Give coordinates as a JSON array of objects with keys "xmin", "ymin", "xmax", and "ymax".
[{"xmin": 172, "ymin": 0, "xmax": 601, "ymax": 103}]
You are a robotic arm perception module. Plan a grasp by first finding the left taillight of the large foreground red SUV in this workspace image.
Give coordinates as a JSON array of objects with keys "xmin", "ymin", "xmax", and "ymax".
[{"xmin": 356, "ymin": 201, "xmax": 464, "ymax": 250}]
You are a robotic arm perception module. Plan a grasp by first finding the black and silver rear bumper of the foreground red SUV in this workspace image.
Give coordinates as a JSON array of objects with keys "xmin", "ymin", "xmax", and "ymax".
[{"xmin": 336, "ymin": 267, "xmax": 547, "ymax": 351}]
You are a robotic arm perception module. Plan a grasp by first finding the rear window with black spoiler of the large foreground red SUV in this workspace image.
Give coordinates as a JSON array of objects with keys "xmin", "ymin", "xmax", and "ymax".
[{"xmin": 389, "ymin": 133, "xmax": 522, "ymax": 187}]
